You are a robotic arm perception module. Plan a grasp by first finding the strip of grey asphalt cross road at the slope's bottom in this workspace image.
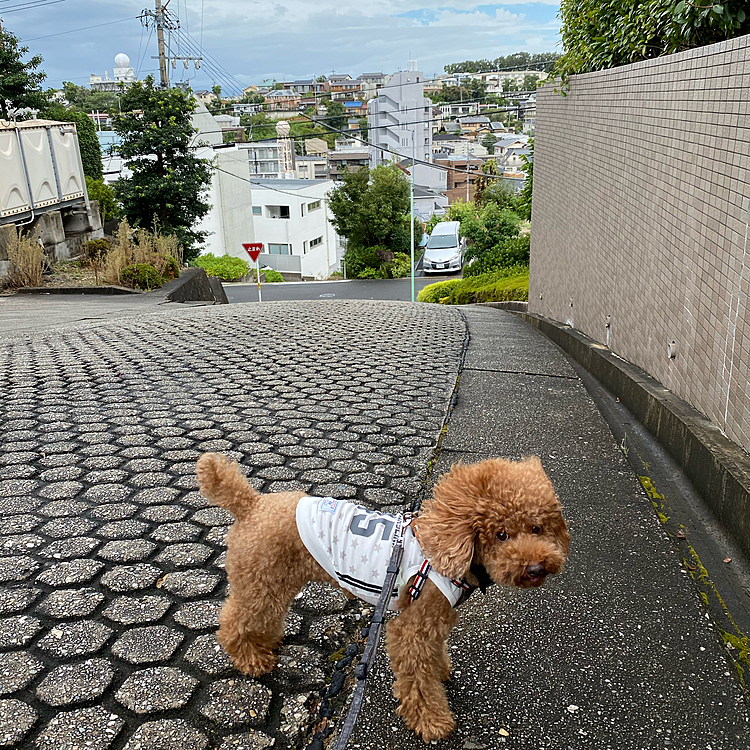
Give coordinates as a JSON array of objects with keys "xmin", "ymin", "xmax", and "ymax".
[{"xmin": 224, "ymin": 274, "xmax": 460, "ymax": 304}]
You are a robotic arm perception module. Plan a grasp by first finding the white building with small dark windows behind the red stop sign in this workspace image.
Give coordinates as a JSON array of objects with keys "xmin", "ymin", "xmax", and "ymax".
[{"xmin": 197, "ymin": 143, "xmax": 341, "ymax": 279}]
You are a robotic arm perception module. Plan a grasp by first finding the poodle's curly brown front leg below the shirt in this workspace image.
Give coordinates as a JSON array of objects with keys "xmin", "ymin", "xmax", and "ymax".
[{"xmin": 387, "ymin": 582, "xmax": 458, "ymax": 742}]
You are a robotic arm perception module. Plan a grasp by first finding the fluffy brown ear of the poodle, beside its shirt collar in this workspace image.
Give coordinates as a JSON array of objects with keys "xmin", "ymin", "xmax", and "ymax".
[{"xmin": 417, "ymin": 464, "xmax": 476, "ymax": 579}]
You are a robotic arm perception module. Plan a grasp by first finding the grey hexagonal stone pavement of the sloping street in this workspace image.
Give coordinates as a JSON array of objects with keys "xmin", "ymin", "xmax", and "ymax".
[{"xmin": 0, "ymin": 301, "xmax": 465, "ymax": 750}]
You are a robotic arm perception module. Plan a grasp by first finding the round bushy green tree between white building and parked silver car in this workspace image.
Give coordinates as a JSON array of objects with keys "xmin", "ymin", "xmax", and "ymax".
[{"xmin": 328, "ymin": 165, "xmax": 420, "ymax": 253}]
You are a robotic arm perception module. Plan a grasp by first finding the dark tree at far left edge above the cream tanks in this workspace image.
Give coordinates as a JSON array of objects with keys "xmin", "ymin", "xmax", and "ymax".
[{"xmin": 0, "ymin": 27, "xmax": 48, "ymax": 120}]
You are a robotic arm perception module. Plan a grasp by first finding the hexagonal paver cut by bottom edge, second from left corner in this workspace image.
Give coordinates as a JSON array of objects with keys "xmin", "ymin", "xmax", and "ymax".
[{"xmin": 36, "ymin": 706, "xmax": 125, "ymax": 750}]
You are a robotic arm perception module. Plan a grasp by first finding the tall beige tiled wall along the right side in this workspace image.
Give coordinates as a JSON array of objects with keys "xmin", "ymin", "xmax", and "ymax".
[{"xmin": 529, "ymin": 36, "xmax": 750, "ymax": 450}]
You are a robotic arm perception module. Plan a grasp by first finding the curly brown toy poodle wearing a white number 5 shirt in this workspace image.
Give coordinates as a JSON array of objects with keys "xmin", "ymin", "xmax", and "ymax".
[{"xmin": 197, "ymin": 453, "xmax": 570, "ymax": 742}]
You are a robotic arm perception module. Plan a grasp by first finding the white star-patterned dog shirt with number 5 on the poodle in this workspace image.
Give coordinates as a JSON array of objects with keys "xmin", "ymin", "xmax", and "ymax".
[{"xmin": 297, "ymin": 497, "xmax": 470, "ymax": 611}]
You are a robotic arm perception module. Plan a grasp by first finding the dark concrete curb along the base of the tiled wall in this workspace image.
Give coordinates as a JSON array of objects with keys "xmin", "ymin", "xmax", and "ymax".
[{"xmin": 514, "ymin": 312, "xmax": 750, "ymax": 557}]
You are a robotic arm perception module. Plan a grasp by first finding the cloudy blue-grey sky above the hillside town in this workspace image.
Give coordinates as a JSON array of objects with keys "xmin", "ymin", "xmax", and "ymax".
[{"xmin": 5, "ymin": 0, "xmax": 560, "ymax": 93}]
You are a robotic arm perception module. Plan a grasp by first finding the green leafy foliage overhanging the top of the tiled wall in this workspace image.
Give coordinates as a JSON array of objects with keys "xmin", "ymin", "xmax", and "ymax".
[{"xmin": 553, "ymin": 0, "xmax": 750, "ymax": 82}]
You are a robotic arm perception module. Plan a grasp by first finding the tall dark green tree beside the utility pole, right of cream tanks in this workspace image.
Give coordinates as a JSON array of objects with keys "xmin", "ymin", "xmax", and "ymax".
[{"xmin": 114, "ymin": 76, "xmax": 211, "ymax": 260}]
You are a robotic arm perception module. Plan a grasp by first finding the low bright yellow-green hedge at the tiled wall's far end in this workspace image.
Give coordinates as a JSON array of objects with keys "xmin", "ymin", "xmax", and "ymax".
[{"xmin": 417, "ymin": 266, "xmax": 529, "ymax": 305}]
